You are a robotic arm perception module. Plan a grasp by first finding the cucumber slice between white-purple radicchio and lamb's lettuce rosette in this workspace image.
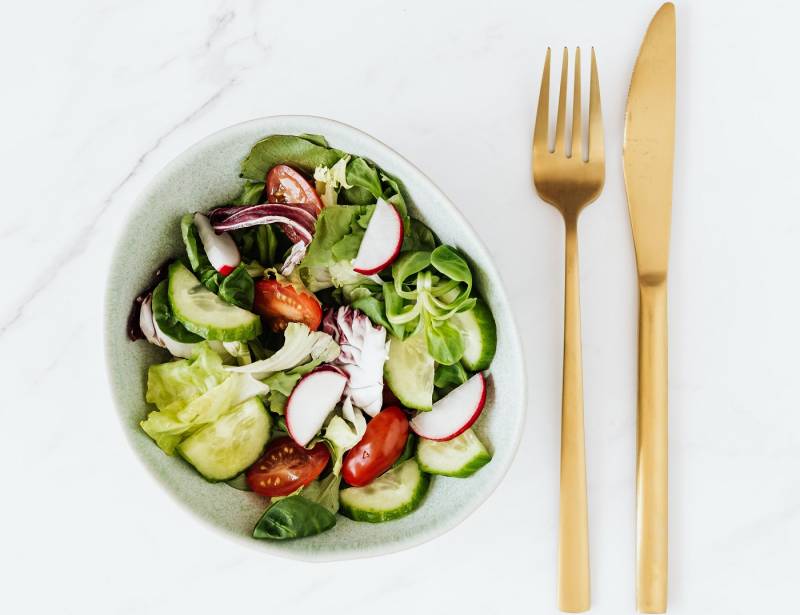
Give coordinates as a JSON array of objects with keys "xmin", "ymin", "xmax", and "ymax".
[{"xmin": 384, "ymin": 330, "xmax": 434, "ymax": 410}]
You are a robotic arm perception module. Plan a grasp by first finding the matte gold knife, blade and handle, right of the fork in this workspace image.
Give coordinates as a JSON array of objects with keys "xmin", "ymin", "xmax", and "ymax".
[{"xmin": 622, "ymin": 2, "xmax": 675, "ymax": 613}]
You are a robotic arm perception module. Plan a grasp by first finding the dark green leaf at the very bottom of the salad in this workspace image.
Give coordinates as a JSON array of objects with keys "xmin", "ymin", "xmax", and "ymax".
[{"xmin": 253, "ymin": 494, "xmax": 338, "ymax": 540}]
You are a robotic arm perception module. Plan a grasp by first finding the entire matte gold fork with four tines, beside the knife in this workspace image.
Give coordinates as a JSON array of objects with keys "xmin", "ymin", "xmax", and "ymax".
[{"xmin": 533, "ymin": 47, "xmax": 605, "ymax": 613}]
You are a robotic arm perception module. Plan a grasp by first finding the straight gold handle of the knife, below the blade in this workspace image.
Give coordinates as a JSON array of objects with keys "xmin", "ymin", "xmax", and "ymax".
[{"xmin": 636, "ymin": 279, "xmax": 668, "ymax": 613}]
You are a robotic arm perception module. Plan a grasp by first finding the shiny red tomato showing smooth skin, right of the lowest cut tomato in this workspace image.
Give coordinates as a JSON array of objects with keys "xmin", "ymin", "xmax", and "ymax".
[{"xmin": 342, "ymin": 406, "xmax": 408, "ymax": 487}]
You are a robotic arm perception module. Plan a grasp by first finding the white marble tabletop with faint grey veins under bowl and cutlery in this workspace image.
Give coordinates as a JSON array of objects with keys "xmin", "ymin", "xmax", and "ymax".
[{"xmin": 0, "ymin": 0, "xmax": 800, "ymax": 615}]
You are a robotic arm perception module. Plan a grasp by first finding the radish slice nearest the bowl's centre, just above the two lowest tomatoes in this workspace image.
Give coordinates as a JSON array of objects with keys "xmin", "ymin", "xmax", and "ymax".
[{"xmin": 286, "ymin": 365, "xmax": 347, "ymax": 446}]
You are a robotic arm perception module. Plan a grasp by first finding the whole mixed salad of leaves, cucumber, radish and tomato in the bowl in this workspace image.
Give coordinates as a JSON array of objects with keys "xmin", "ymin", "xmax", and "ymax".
[{"xmin": 128, "ymin": 135, "xmax": 496, "ymax": 540}]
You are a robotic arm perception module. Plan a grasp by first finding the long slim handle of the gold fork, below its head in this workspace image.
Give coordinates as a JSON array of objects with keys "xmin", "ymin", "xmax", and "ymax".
[{"xmin": 558, "ymin": 215, "xmax": 589, "ymax": 613}]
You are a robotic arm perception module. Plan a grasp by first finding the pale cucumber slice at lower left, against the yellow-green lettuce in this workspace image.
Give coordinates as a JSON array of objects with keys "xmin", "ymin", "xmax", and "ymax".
[{"xmin": 178, "ymin": 397, "xmax": 272, "ymax": 481}]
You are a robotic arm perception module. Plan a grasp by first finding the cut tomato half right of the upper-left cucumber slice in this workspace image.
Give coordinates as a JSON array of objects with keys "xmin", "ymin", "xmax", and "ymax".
[{"xmin": 253, "ymin": 280, "xmax": 322, "ymax": 331}]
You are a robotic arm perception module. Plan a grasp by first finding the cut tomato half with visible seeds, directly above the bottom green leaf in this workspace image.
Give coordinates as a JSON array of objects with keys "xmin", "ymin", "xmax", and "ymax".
[{"xmin": 247, "ymin": 437, "xmax": 331, "ymax": 498}]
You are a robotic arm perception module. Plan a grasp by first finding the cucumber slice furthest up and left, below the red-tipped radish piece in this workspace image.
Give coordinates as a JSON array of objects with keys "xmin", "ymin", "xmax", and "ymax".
[{"xmin": 169, "ymin": 262, "xmax": 261, "ymax": 342}]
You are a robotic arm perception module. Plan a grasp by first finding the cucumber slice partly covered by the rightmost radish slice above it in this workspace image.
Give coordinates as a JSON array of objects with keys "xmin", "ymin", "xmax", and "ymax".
[{"xmin": 417, "ymin": 429, "xmax": 492, "ymax": 478}]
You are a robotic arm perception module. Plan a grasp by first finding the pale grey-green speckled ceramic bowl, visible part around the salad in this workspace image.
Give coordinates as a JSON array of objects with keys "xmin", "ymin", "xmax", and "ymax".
[{"xmin": 105, "ymin": 116, "xmax": 526, "ymax": 561}]
